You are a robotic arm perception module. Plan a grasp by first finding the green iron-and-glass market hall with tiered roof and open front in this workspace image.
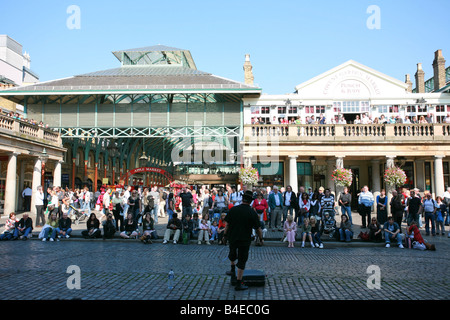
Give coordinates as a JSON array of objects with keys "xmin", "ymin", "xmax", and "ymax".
[{"xmin": 1, "ymin": 45, "xmax": 261, "ymax": 196}]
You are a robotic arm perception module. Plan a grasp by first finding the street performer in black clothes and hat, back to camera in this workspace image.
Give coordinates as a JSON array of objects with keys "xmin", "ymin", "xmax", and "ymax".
[{"xmin": 224, "ymin": 191, "xmax": 263, "ymax": 290}]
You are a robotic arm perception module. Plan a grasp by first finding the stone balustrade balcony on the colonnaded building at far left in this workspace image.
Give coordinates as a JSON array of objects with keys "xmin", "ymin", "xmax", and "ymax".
[{"xmin": 0, "ymin": 115, "xmax": 62, "ymax": 147}]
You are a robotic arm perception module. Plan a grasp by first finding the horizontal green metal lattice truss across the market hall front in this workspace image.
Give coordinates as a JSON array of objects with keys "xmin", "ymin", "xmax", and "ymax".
[{"xmin": 57, "ymin": 126, "xmax": 240, "ymax": 138}]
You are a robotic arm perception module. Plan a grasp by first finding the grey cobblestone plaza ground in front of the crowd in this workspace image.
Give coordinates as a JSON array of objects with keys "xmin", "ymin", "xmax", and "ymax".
[{"xmin": 0, "ymin": 215, "xmax": 450, "ymax": 301}]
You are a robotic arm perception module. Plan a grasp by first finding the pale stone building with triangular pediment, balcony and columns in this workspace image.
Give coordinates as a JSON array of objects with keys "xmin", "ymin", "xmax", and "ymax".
[{"xmin": 243, "ymin": 50, "xmax": 450, "ymax": 209}]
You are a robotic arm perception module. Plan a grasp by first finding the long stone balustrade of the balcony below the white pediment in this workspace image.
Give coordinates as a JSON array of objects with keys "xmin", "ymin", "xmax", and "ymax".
[{"xmin": 244, "ymin": 123, "xmax": 450, "ymax": 144}]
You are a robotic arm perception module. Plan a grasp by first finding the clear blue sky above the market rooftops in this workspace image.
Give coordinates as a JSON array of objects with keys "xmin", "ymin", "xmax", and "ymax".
[{"xmin": 0, "ymin": 0, "xmax": 450, "ymax": 94}]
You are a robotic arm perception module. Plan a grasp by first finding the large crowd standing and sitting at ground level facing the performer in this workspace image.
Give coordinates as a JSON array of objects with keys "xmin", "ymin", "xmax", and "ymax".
[{"xmin": 1, "ymin": 185, "xmax": 450, "ymax": 249}]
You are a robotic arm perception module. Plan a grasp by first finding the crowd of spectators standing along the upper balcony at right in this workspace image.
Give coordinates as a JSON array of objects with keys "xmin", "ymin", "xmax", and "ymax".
[{"xmin": 251, "ymin": 113, "xmax": 450, "ymax": 125}]
